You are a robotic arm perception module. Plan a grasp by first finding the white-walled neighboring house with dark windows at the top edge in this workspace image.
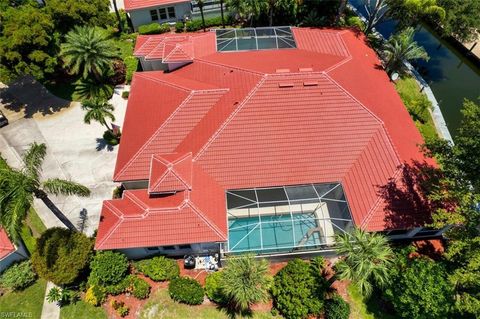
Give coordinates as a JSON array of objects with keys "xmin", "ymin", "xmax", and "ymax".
[{"xmin": 124, "ymin": 0, "xmax": 225, "ymax": 31}]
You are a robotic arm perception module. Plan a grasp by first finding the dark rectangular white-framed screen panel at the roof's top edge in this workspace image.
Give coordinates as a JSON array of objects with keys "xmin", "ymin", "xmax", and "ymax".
[{"xmin": 215, "ymin": 27, "xmax": 297, "ymax": 52}]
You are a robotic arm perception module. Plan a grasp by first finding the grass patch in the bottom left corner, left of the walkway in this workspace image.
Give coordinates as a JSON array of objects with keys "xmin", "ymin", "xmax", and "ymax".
[{"xmin": 0, "ymin": 279, "xmax": 47, "ymax": 318}]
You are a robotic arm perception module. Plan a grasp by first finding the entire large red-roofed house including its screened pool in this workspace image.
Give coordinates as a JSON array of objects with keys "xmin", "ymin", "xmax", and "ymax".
[{"xmin": 95, "ymin": 27, "xmax": 441, "ymax": 258}]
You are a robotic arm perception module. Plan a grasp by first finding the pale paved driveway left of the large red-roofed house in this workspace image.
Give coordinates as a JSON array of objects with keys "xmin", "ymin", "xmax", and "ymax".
[{"xmin": 0, "ymin": 84, "xmax": 126, "ymax": 234}]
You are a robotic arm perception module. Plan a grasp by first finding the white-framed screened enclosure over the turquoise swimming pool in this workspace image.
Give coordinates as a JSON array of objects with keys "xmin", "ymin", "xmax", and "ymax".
[{"xmin": 226, "ymin": 183, "xmax": 353, "ymax": 253}]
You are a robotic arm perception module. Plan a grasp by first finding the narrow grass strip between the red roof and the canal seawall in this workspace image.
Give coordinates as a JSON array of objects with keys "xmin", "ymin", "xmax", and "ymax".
[{"xmin": 395, "ymin": 77, "xmax": 438, "ymax": 140}]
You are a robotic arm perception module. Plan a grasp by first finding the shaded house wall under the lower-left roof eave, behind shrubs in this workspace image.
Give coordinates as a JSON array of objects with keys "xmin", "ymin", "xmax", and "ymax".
[{"xmin": 117, "ymin": 243, "xmax": 220, "ymax": 259}]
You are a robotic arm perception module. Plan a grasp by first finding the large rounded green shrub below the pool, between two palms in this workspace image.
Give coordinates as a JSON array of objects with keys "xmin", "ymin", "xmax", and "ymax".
[{"xmin": 272, "ymin": 259, "xmax": 327, "ymax": 319}]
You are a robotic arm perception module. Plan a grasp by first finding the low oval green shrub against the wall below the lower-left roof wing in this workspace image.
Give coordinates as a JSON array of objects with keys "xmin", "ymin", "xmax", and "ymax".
[{"xmin": 135, "ymin": 256, "xmax": 180, "ymax": 281}]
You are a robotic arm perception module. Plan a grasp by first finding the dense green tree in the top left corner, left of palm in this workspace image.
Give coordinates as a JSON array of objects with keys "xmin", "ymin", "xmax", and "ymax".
[{"xmin": 0, "ymin": 4, "xmax": 59, "ymax": 82}]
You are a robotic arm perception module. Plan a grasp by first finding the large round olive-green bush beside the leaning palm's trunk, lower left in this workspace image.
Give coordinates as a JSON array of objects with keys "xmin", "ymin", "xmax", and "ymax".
[{"xmin": 31, "ymin": 227, "xmax": 93, "ymax": 285}]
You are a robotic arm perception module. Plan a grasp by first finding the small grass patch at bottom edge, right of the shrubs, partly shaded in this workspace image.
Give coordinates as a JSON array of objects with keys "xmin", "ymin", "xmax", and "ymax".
[{"xmin": 347, "ymin": 285, "xmax": 401, "ymax": 319}]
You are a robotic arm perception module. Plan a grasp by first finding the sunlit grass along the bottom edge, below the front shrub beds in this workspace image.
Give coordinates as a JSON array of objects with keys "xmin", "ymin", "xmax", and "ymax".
[{"xmin": 140, "ymin": 289, "xmax": 281, "ymax": 319}]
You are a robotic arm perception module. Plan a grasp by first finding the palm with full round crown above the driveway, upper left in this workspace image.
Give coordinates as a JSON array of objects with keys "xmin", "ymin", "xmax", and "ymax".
[{"xmin": 60, "ymin": 26, "xmax": 119, "ymax": 82}]
